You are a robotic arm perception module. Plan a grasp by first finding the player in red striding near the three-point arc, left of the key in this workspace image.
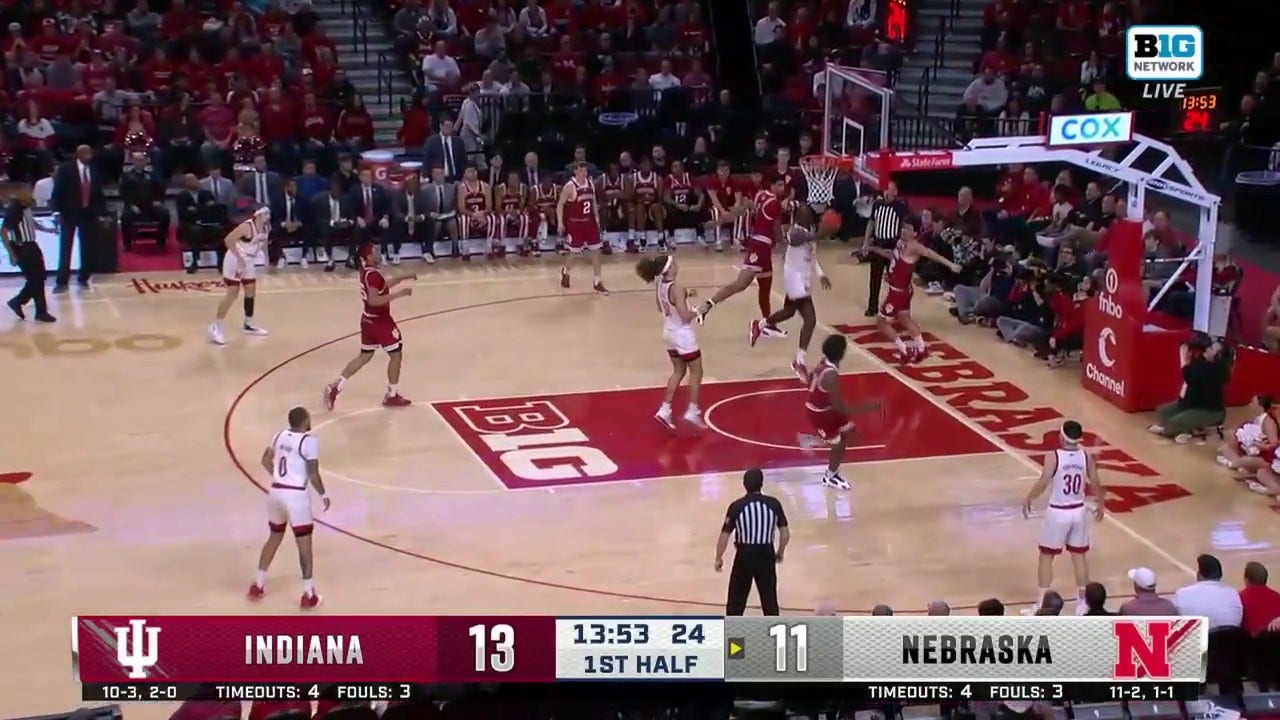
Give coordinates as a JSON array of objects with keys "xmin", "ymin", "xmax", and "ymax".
[{"xmin": 321, "ymin": 245, "xmax": 417, "ymax": 410}]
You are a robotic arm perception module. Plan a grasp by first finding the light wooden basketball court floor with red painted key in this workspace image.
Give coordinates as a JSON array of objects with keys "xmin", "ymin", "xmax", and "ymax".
[{"xmin": 0, "ymin": 64, "xmax": 1280, "ymax": 717}]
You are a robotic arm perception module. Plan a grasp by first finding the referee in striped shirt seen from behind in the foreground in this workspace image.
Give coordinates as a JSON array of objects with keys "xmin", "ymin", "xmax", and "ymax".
[{"xmin": 716, "ymin": 469, "xmax": 791, "ymax": 615}]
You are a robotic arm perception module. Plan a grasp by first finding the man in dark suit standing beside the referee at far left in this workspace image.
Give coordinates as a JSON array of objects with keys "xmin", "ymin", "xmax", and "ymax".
[{"xmin": 51, "ymin": 145, "xmax": 106, "ymax": 292}]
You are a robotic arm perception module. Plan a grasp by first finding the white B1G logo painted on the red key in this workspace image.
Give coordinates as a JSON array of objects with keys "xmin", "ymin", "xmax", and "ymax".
[{"xmin": 452, "ymin": 400, "xmax": 618, "ymax": 482}]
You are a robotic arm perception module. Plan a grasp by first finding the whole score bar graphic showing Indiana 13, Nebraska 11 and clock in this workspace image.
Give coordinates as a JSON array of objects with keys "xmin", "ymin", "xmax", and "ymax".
[{"xmin": 72, "ymin": 616, "xmax": 1208, "ymax": 701}]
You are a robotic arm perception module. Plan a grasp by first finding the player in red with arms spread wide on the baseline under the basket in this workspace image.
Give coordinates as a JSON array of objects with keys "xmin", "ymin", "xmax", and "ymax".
[{"xmin": 868, "ymin": 217, "xmax": 960, "ymax": 363}]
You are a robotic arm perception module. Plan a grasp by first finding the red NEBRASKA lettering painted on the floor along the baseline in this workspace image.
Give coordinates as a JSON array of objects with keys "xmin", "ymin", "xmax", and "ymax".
[{"xmin": 836, "ymin": 325, "xmax": 1192, "ymax": 512}]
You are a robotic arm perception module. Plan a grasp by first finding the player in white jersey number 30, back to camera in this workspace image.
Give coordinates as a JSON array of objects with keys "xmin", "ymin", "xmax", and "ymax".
[{"xmin": 1023, "ymin": 420, "xmax": 1103, "ymax": 615}]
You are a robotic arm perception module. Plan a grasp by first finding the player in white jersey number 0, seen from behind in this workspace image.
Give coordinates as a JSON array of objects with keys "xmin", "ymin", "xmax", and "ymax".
[{"xmin": 248, "ymin": 407, "xmax": 329, "ymax": 609}]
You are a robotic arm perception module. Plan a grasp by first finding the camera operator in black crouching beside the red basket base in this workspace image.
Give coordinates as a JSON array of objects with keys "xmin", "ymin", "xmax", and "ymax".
[{"xmin": 1147, "ymin": 332, "xmax": 1231, "ymax": 443}]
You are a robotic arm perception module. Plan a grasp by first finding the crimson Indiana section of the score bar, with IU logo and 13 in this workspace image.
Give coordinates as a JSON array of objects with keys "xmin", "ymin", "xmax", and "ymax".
[{"xmin": 73, "ymin": 615, "xmax": 556, "ymax": 684}]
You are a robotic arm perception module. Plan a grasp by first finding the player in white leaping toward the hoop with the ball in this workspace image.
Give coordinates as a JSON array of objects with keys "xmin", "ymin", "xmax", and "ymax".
[{"xmin": 750, "ymin": 205, "xmax": 831, "ymax": 383}]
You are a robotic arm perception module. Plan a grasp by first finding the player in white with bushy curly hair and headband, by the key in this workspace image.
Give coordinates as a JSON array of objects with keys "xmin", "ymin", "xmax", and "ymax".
[{"xmin": 636, "ymin": 255, "xmax": 705, "ymax": 430}]
